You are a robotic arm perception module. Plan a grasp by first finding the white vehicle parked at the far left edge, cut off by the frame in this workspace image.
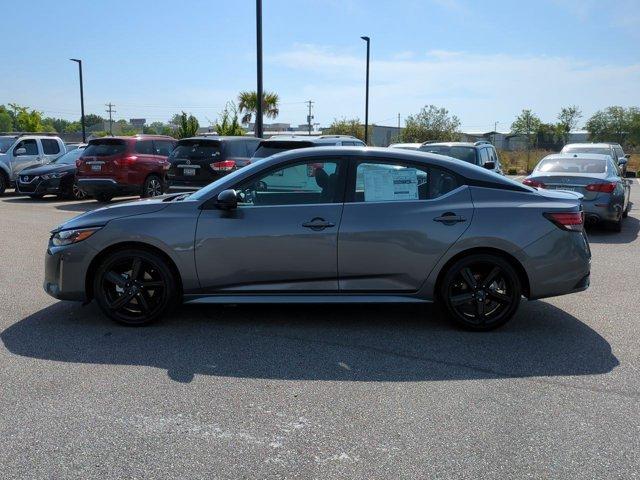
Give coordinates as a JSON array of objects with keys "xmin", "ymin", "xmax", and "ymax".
[{"xmin": 0, "ymin": 133, "xmax": 67, "ymax": 195}]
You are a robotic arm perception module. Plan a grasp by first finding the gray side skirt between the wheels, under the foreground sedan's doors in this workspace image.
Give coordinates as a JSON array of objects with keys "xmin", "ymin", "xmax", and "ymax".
[{"xmin": 183, "ymin": 294, "xmax": 432, "ymax": 304}]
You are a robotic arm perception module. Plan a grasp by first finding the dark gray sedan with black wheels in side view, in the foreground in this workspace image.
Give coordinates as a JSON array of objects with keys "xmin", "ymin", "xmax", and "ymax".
[{"xmin": 44, "ymin": 147, "xmax": 590, "ymax": 330}]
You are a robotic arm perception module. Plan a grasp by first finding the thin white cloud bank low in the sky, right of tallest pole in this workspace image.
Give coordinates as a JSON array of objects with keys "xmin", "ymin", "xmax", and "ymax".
[{"xmin": 269, "ymin": 45, "xmax": 640, "ymax": 128}]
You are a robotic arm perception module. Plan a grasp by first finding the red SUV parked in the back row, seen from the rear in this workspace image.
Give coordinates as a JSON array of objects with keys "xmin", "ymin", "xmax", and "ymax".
[{"xmin": 76, "ymin": 135, "xmax": 176, "ymax": 202}]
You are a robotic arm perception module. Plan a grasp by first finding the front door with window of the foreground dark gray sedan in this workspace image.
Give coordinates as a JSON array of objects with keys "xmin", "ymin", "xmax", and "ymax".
[{"xmin": 195, "ymin": 158, "xmax": 344, "ymax": 293}]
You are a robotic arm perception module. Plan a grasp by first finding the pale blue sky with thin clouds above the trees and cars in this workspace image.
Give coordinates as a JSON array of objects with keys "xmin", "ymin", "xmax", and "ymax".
[{"xmin": 5, "ymin": 0, "xmax": 640, "ymax": 130}]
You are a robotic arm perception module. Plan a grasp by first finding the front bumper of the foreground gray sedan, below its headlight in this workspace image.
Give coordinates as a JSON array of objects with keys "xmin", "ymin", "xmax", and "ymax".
[{"xmin": 43, "ymin": 241, "xmax": 97, "ymax": 301}]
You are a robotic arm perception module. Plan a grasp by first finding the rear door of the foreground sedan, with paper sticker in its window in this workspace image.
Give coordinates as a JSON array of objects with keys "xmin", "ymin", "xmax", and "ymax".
[{"xmin": 338, "ymin": 158, "xmax": 473, "ymax": 292}]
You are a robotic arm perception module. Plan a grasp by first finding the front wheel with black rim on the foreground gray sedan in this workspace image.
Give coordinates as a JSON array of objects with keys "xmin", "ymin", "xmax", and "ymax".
[{"xmin": 93, "ymin": 249, "xmax": 178, "ymax": 327}]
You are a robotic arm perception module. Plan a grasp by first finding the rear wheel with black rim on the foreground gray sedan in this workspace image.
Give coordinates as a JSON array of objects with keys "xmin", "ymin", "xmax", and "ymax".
[{"xmin": 438, "ymin": 254, "xmax": 522, "ymax": 331}]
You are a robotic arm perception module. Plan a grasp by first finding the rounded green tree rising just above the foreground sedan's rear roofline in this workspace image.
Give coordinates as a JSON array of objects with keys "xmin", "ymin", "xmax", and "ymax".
[{"xmin": 400, "ymin": 105, "xmax": 460, "ymax": 142}]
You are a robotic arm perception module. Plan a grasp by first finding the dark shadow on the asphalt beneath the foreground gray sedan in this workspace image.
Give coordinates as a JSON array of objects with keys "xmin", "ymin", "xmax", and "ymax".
[{"xmin": 0, "ymin": 301, "xmax": 618, "ymax": 382}]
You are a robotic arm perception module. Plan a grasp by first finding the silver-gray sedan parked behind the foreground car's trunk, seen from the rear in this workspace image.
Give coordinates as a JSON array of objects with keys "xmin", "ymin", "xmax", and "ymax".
[{"xmin": 523, "ymin": 153, "xmax": 631, "ymax": 232}]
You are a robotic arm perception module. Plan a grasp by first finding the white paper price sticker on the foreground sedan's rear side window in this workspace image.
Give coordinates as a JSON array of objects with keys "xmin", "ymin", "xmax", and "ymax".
[{"xmin": 364, "ymin": 168, "xmax": 418, "ymax": 202}]
